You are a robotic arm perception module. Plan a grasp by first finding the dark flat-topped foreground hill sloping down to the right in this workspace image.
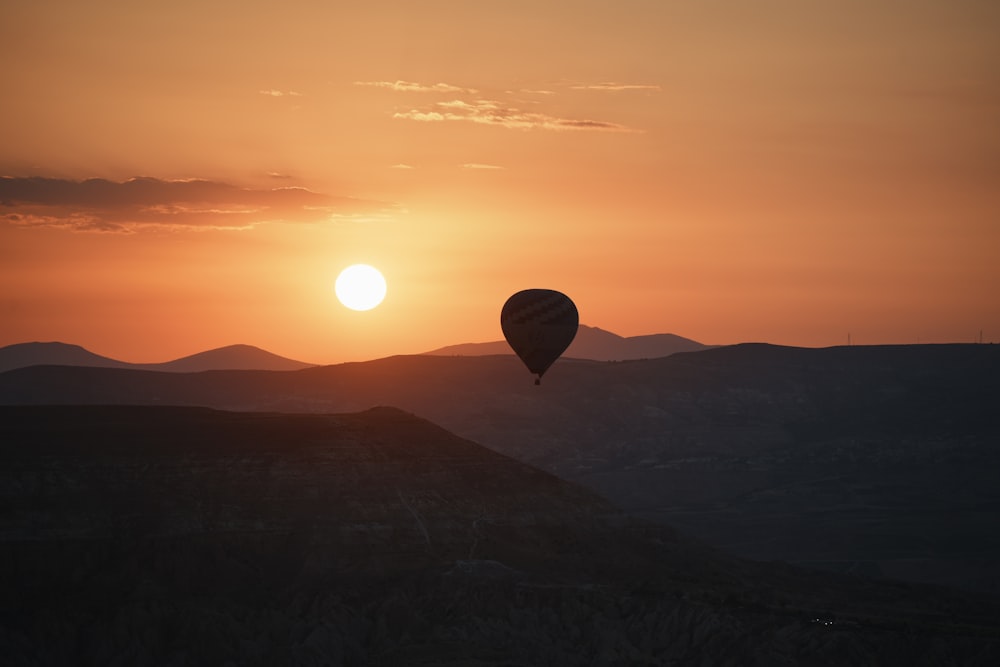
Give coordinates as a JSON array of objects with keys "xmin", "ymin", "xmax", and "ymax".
[{"xmin": 0, "ymin": 406, "xmax": 1000, "ymax": 666}]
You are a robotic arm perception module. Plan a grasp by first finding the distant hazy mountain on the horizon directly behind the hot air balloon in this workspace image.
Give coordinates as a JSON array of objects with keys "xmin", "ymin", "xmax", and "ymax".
[{"xmin": 426, "ymin": 324, "xmax": 711, "ymax": 361}]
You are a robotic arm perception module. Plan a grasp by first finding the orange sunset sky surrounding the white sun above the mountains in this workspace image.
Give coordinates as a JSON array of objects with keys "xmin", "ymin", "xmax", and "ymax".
[{"xmin": 0, "ymin": 0, "xmax": 1000, "ymax": 363}]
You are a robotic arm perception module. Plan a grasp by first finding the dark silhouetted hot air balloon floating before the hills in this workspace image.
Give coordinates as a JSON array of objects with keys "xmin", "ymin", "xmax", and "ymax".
[{"xmin": 500, "ymin": 289, "xmax": 580, "ymax": 384}]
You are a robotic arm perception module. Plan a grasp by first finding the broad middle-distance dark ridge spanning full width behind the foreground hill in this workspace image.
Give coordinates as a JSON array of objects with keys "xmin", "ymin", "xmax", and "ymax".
[{"xmin": 0, "ymin": 345, "xmax": 1000, "ymax": 595}]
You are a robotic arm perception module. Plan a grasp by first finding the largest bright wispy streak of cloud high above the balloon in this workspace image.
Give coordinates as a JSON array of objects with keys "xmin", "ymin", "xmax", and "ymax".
[{"xmin": 393, "ymin": 100, "xmax": 636, "ymax": 132}]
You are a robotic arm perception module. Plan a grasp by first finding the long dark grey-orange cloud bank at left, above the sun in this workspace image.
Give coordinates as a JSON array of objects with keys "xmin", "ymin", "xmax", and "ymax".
[{"xmin": 0, "ymin": 176, "xmax": 386, "ymax": 233}]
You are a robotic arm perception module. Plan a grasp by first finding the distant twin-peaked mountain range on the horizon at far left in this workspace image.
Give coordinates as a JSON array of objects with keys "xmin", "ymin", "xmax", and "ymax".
[{"xmin": 0, "ymin": 343, "xmax": 312, "ymax": 373}]
